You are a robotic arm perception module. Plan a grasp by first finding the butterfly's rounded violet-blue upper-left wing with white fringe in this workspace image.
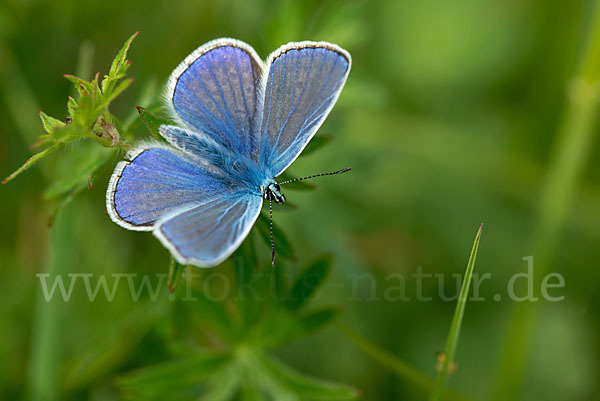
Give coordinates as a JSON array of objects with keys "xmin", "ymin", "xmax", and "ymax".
[{"xmin": 167, "ymin": 39, "xmax": 263, "ymax": 154}]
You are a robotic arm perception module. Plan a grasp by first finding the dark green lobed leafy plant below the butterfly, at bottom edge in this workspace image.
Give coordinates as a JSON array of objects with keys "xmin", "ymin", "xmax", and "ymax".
[{"xmin": 119, "ymin": 248, "xmax": 358, "ymax": 400}]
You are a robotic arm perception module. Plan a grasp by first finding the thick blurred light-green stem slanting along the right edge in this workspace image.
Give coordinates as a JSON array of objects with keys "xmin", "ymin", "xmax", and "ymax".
[{"xmin": 494, "ymin": 5, "xmax": 600, "ymax": 401}]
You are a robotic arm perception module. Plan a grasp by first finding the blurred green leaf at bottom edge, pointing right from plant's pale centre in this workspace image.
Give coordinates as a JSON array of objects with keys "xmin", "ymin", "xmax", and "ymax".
[{"xmin": 259, "ymin": 355, "xmax": 360, "ymax": 401}]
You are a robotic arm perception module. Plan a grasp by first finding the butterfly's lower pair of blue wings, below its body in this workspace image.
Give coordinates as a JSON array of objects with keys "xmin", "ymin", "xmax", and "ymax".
[{"xmin": 108, "ymin": 148, "xmax": 262, "ymax": 266}]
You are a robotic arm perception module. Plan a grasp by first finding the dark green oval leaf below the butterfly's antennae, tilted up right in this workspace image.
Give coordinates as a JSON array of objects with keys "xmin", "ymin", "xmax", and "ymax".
[{"xmin": 285, "ymin": 255, "xmax": 333, "ymax": 310}]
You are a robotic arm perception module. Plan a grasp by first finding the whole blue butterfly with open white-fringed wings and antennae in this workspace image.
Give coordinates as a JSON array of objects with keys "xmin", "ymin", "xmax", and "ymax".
[{"xmin": 106, "ymin": 39, "xmax": 351, "ymax": 267}]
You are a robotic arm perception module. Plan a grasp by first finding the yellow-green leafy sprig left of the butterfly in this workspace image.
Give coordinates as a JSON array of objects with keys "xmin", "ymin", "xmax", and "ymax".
[{"xmin": 2, "ymin": 32, "xmax": 145, "ymax": 224}]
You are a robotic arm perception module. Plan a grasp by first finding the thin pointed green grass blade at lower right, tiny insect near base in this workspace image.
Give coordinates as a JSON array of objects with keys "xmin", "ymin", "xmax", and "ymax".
[{"xmin": 429, "ymin": 224, "xmax": 483, "ymax": 401}]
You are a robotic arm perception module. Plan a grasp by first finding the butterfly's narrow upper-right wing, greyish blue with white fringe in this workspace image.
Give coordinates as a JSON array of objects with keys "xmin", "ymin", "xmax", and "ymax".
[{"xmin": 256, "ymin": 42, "xmax": 351, "ymax": 177}]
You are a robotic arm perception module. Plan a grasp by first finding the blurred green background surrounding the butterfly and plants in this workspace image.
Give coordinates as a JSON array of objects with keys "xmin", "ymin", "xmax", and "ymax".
[{"xmin": 0, "ymin": 0, "xmax": 600, "ymax": 400}]
